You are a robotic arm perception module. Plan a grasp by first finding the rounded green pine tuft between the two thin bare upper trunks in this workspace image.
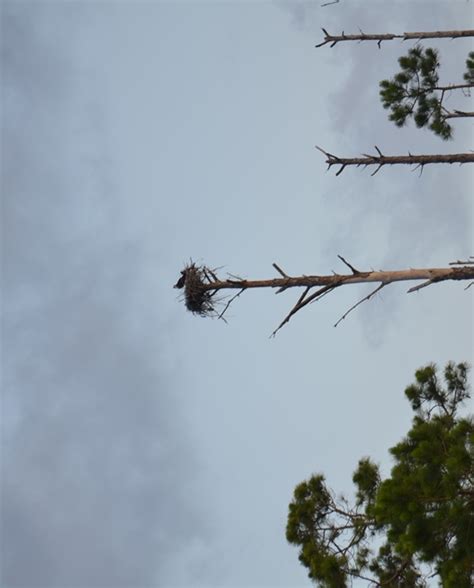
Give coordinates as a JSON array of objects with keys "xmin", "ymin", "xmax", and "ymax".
[{"xmin": 380, "ymin": 45, "xmax": 453, "ymax": 140}]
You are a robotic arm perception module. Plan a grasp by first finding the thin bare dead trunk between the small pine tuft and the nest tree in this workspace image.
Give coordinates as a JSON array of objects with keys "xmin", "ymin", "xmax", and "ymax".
[{"xmin": 316, "ymin": 145, "xmax": 474, "ymax": 176}]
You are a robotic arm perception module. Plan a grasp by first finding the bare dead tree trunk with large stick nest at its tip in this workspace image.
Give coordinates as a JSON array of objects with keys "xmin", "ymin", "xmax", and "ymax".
[{"xmin": 177, "ymin": 256, "xmax": 474, "ymax": 336}]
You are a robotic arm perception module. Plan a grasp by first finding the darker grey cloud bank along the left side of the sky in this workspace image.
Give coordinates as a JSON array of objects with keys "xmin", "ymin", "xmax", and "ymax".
[{"xmin": 2, "ymin": 3, "xmax": 207, "ymax": 588}]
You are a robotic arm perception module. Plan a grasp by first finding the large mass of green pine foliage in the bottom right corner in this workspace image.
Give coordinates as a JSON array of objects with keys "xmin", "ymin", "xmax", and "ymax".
[{"xmin": 286, "ymin": 363, "xmax": 474, "ymax": 588}]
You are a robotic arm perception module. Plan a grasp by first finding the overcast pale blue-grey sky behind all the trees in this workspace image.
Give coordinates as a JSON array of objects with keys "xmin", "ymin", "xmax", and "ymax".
[{"xmin": 1, "ymin": 0, "xmax": 474, "ymax": 588}]
